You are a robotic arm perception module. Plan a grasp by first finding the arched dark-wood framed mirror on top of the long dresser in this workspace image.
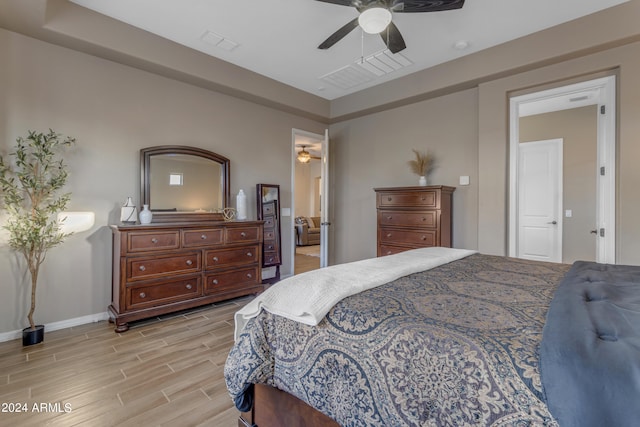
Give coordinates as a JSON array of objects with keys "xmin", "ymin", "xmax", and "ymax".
[{"xmin": 140, "ymin": 145, "xmax": 230, "ymax": 222}]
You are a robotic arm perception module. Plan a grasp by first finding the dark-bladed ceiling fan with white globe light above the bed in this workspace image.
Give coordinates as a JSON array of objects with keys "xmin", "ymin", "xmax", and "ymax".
[{"xmin": 317, "ymin": 0, "xmax": 464, "ymax": 53}]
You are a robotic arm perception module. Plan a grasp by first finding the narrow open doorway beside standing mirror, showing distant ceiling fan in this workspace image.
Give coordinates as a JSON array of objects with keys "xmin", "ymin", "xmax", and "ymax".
[{"xmin": 292, "ymin": 129, "xmax": 329, "ymax": 274}]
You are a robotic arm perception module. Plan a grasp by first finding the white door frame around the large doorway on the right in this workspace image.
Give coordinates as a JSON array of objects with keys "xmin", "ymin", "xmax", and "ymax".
[{"xmin": 508, "ymin": 76, "xmax": 616, "ymax": 264}]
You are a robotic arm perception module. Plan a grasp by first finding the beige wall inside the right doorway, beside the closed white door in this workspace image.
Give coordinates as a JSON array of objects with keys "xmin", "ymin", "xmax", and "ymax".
[{"xmin": 519, "ymin": 105, "xmax": 598, "ymax": 263}]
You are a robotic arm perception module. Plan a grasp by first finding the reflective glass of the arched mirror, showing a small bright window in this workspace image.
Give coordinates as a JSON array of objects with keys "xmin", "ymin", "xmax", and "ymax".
[{"xmin": 149, "ymin": 154, "xmax": 224, "ymax": 212}]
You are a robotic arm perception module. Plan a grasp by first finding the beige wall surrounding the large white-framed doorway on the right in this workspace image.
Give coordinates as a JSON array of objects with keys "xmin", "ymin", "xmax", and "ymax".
[{"xmin": 478, "ymin": 42, "xmax": 640, "ymax": 264}]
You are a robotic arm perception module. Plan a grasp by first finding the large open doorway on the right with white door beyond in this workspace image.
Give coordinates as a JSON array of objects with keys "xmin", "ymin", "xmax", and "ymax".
[{"xmin": 509, "ymin": 76, "xmax": 616, "ymax": 264}]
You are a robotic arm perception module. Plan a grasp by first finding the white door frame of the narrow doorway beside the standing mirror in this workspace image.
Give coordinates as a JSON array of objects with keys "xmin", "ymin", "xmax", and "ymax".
[{"xmin": 289, "ymin": 128, "xmax": 329, "ymax": 276}]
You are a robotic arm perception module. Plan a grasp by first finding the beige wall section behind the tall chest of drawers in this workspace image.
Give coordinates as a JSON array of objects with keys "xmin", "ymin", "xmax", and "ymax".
[{"xmin": 329, "ymin": 89, "xmax": 478, "ymax": 262}]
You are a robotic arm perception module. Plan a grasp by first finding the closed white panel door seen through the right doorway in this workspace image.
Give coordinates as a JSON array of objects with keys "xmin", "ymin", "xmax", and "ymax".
[{"xmin": 517, "ymin": 139, "xmax": 562, "ymax": 262}]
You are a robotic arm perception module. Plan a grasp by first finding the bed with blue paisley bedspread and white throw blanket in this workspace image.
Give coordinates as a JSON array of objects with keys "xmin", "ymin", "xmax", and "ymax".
[{"xmin": 225, "ymin": 248, "xmax": 640, "ymax": 427}]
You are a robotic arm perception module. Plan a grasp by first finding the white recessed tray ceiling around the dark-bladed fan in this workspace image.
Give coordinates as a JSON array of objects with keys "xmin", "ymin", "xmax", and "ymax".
[{"xmin": 71, "ymin": 0, "xmax": 627, "ymax": 100}]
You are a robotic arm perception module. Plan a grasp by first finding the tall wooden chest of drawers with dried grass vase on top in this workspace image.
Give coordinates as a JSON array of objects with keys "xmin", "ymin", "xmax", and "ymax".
[{"xmin": 374, "ymin": 186, "xmax": 455, "ymax": 256}]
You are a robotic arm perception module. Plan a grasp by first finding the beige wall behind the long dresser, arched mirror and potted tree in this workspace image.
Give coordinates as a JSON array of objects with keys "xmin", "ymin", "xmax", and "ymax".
[{"xmin": 0, "ymin": 29, "xmax": 325, "ymax": 333}]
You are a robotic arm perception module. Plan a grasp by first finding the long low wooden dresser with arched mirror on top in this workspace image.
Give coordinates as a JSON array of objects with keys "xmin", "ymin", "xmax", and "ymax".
[{"xmin": 109, "ymin": 221, "xmax": 264, "ymax": 332}]
